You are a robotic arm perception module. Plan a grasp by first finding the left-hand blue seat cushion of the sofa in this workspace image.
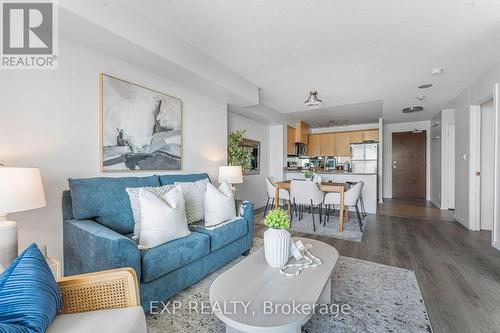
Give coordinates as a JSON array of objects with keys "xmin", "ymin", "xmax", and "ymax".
[{"xmin": 141, "ymin": 232, "xmax": 210, "ymax": 282}]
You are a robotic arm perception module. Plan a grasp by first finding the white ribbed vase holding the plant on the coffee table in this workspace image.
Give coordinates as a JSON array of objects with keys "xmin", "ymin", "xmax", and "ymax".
[{"xmin": 264, "ymin": 228, "xmax": 291, "ymax": 268}]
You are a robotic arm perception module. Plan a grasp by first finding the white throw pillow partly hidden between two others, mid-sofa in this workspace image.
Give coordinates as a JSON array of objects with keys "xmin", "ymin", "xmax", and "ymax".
[{"xmin": 175, "ymin": 178, "xmax": 209, "ymax": 223}]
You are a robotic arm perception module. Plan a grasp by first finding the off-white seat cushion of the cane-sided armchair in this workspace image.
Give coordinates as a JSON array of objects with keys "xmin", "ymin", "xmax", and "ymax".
[{"xmin": 46, "ymin": 306, "xmax": 147, "ymax": 333}]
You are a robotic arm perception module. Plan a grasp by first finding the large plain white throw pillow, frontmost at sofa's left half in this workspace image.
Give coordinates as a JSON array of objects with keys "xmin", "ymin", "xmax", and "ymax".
[{"xmin": 139, "ymin": 186, "xmax": 191, "ymax": 249}]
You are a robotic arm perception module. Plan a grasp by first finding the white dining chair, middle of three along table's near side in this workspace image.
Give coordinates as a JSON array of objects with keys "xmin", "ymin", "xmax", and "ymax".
[{"xmin": 290, "ymin": 180, "xmax": 325, "ymax": 231}]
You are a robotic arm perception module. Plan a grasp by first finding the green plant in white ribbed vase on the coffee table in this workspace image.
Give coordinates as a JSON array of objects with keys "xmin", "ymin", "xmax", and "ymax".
[{"xmin": 264, "ymin": 208, "xmax": 291, "ymax": 268}]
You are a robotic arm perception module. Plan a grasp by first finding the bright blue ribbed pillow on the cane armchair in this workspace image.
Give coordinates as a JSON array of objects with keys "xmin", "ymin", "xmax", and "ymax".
[{"xmin": 0, "ymin": 244, "xmax": 61, "ymax": 333}]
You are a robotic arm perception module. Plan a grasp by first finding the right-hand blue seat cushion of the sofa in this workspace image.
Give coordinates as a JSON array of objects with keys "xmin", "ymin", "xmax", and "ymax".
[{"xmin": 189, "ymin": 217, "xmax": 248, "ymax": 252}]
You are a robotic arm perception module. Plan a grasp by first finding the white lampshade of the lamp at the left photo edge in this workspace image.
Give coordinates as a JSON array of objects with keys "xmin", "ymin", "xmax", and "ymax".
[{"xmin": 0, "ymin": 167, "xmax": 46, "ymax": 214}]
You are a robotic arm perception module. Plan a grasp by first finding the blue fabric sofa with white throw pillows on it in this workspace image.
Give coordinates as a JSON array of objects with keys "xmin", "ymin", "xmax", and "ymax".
[{"xmin": 62, "ymin": 174, "xmax": 253, "ymax": 311}]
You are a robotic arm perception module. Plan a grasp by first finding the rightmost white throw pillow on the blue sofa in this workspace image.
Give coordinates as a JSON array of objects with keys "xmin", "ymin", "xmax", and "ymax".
[{"xmin": 205, "ymin": 181, "xmax": 236, "ymax": 227}]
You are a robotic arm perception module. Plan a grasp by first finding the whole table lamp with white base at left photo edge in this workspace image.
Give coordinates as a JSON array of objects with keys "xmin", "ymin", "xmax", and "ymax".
[{"xmin": 0, "ymin": 166, "xmax": 46, "ymax": 268}]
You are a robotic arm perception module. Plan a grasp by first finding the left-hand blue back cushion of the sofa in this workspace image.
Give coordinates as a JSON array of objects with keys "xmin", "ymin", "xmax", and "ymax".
[{"xmin": 69, "ymin": 176, "xmax": 160, "ymax": 234}]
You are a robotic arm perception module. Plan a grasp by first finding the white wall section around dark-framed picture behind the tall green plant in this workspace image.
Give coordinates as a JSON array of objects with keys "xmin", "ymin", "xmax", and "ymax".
[{"xmin": 228, "ymin": 112, "xmax": 270, "ymax": 208}]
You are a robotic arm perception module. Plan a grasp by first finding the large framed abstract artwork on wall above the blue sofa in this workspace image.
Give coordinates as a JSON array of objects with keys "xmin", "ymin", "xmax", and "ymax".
[{"xmin": 100, "ymin": 74, "xmax": 182, "ymax": 172}]
